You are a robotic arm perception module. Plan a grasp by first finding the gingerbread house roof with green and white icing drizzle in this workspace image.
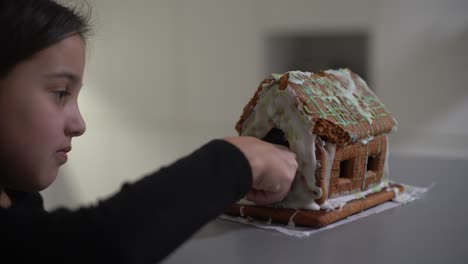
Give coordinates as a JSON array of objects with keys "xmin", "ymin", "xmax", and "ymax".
[{"xmin": 236, "ymin": 69, "xmax": 397, "ymax": 144}]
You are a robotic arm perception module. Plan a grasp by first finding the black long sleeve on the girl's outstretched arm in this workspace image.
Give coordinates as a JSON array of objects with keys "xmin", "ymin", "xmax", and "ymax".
[{"xmin": 0, "ymin": 140, "xmax": 252, "ymax": 263}]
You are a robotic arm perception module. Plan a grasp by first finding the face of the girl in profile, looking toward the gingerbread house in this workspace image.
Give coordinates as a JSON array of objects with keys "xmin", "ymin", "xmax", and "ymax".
[{"xmin": 0, "ymin": 34, "xmax": 85, "ymax": 191}]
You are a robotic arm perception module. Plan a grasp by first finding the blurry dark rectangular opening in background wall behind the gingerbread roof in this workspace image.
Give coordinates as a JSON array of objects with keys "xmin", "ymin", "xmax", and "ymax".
[{"xmin": 265, "ymin": 32, "xmax": 369, "ymax": 84}]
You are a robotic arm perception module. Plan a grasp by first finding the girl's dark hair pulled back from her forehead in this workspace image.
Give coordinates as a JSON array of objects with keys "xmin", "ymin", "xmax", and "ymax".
[{"xmin": 0, "ymin": 0, "xmax": 91, "ymax": 79}]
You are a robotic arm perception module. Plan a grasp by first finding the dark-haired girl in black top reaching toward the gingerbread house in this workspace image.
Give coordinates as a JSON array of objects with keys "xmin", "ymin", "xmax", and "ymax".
[{"xmin": 0, "ymin": 0, "xmax": 297, "ymax": 263}]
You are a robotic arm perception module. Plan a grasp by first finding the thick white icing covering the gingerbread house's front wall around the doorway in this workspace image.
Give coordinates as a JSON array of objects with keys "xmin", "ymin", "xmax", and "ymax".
[{"xmin": 242, "ymin": 85, "xmax": 322, "ymax": 210}]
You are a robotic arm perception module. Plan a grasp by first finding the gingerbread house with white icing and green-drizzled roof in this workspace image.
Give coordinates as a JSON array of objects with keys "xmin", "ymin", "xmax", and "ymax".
[{"xmin": 227, "ymin": 69, "xmax": 401, "ymax": 226}]
